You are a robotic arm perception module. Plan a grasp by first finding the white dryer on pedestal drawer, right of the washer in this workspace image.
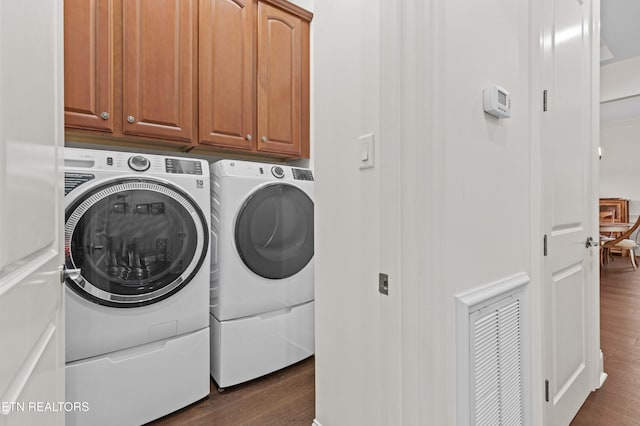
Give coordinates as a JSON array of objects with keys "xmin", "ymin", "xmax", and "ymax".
[{"xmin": 211, "ymin": 160, "xmax": 314, "ymax": 388}]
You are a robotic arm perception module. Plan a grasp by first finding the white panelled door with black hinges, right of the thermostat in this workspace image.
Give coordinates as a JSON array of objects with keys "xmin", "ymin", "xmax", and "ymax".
[{"xmin": 542, "ymin": 0, "xmax": 599, "ymax": 425}]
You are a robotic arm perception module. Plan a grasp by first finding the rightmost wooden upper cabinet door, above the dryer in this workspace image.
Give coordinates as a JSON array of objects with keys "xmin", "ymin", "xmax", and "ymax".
[{"xmin": 257, "ymin": 3, "xmax": 302, "ymax": 155}]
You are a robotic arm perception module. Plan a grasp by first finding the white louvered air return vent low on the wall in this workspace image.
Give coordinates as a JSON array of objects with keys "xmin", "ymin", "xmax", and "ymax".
[{"xmin": 456, "ymin": 274, "xmax": 529, "ymax": 426}]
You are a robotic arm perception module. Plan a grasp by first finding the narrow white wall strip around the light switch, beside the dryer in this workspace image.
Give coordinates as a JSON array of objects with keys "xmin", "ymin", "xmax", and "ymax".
[{"xmin": 312, "ymin": 0, "xmax": 382, "ymax": 426}]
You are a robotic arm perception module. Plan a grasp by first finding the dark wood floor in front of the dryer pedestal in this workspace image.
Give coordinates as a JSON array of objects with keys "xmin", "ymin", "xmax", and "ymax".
[{"xmin": 149, "ymin": 357, "xmax": 315, "ymax": 426}]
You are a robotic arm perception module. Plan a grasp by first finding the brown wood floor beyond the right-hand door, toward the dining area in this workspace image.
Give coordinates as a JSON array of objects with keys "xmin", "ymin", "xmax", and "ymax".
[{"xmin": 571, "ymin": 257, "xmax": 640, "ymax": 426}]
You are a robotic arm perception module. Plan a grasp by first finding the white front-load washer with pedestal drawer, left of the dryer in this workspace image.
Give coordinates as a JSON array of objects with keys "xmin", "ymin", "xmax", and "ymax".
[{"xmin": 64, "ymin": 148, "xmax": 210, "ymax": 425}]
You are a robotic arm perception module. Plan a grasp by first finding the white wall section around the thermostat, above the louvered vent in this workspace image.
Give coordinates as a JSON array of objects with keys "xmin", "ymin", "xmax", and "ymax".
[{"xmin": 416, "ymin": 0, "xmax": 539, "ymax": 425}]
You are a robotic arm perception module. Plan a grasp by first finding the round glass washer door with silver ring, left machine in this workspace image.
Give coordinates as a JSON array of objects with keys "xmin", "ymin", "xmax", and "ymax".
[{"xmin": 65, "ymin": 179, "xmax": 209, "ymax": 307}]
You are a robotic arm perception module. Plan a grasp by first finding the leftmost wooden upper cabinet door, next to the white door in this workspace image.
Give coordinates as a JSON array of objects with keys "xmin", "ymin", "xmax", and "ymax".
[{"xmin": 64, "ymin": 0, "xmax": 113, "ymax": 132}]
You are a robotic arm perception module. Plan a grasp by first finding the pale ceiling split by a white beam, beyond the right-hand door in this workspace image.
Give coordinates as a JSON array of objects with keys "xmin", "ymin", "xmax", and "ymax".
[{"xmin": 600, "ymin": 0, "xmax": 640, "ymax": 122}]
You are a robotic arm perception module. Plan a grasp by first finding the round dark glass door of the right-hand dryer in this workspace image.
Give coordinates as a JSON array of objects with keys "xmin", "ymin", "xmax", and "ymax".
[{"xmin": 235, "ymin": 183, "xmax": 313, "ymax": 279}]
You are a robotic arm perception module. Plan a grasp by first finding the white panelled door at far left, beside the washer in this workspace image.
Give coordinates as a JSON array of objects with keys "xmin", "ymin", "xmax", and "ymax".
[{"xmin": 0, "ymin": 0, "xmax": 65, "ymax": 426}]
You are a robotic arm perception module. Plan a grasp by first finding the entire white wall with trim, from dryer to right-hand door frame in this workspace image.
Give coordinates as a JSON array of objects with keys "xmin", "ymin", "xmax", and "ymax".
[{"xmin": 314, "ymin": 0, "xmax": 538, "ymax": 426}]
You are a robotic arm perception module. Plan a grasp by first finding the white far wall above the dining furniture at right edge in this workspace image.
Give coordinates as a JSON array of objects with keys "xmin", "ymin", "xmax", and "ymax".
[{"xmin": 600, "ymin": 119, "xmax": 640, "ymax": 221}]
